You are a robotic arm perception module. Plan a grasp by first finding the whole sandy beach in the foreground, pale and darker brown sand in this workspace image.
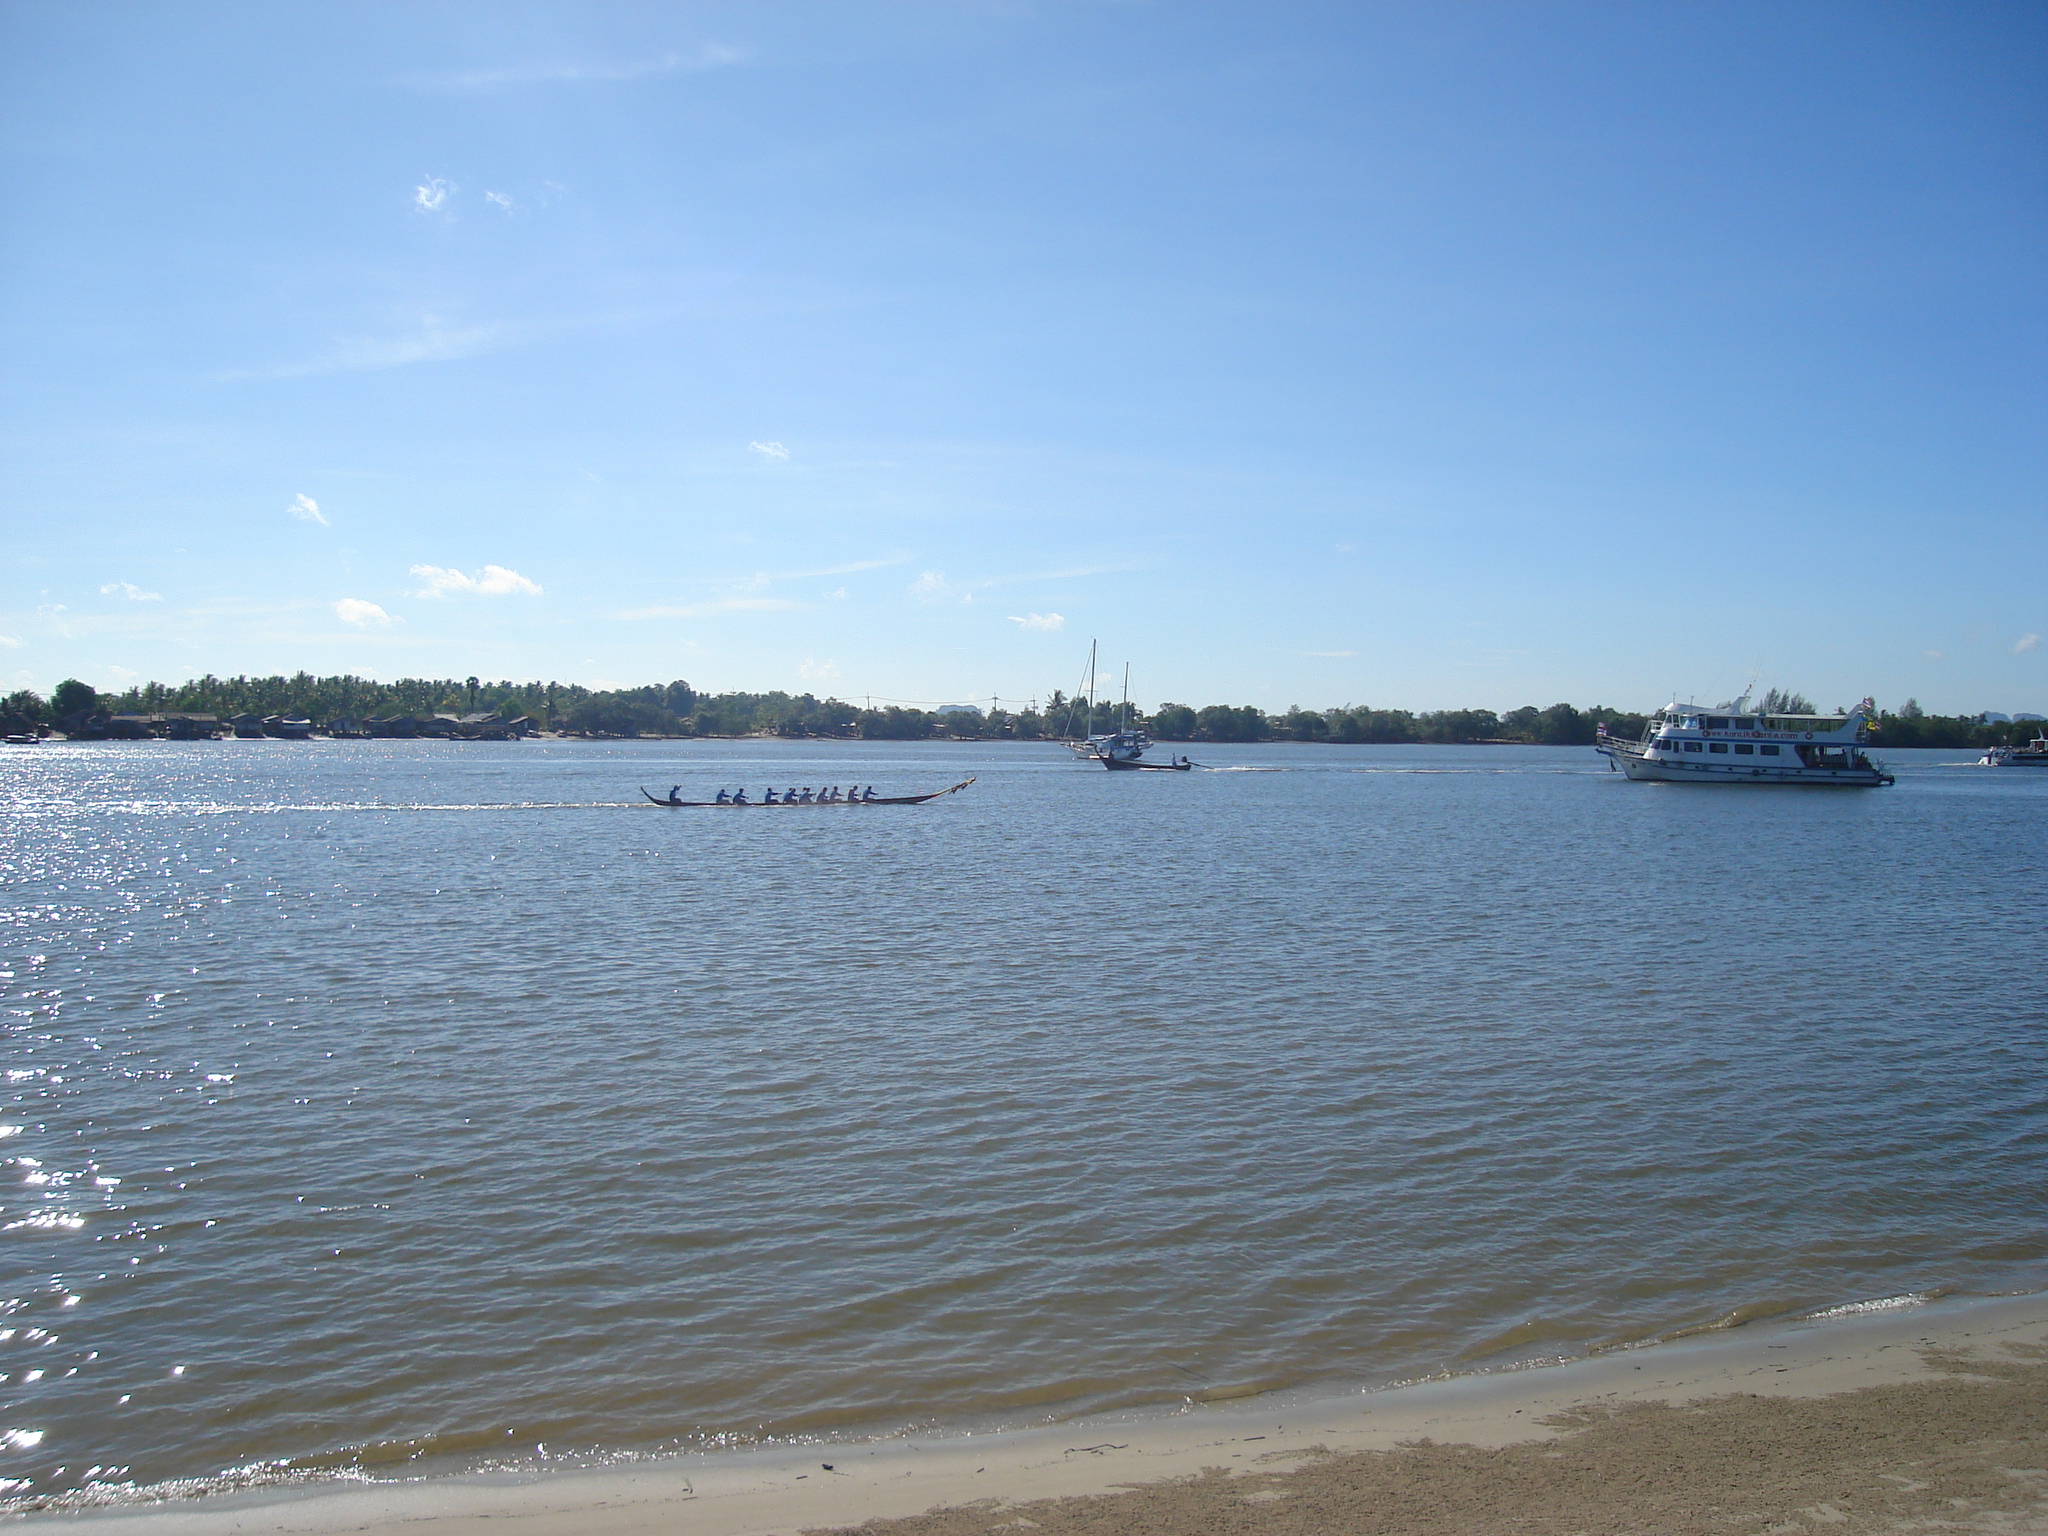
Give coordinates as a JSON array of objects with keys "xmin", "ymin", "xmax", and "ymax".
[{"xmin": 29, "ymin": 1294, "xmax": 2048, "ymax": 1536}]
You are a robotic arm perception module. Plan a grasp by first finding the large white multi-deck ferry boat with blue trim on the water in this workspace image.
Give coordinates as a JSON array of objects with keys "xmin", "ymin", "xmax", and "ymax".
[{"xmin": 1593, "ymin": 698, "xmax": 1892, "ymax": 788}]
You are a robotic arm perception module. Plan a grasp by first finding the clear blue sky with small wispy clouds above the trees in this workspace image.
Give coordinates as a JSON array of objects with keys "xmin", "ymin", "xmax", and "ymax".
[{"xmin": 0, "ymin": 0, "xmax": 2048, "ymax": 711}]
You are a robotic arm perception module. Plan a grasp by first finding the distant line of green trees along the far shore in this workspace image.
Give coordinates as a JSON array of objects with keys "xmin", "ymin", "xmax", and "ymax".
[{"xmin": 0, "ymin": 672, "xmax": 2048, "ymax": 748}]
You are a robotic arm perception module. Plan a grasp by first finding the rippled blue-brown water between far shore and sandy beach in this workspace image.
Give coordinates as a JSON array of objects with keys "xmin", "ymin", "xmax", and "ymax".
[{"xmin": 0, "ymin": 741, "xmax": 2048, "ymax": 1499}]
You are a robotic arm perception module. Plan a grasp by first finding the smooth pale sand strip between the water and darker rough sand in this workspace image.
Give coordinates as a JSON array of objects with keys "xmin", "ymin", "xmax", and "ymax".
[{"xmin": 36, "ymin": 1292, "xmax": 2048, "ymax": 1536}]
